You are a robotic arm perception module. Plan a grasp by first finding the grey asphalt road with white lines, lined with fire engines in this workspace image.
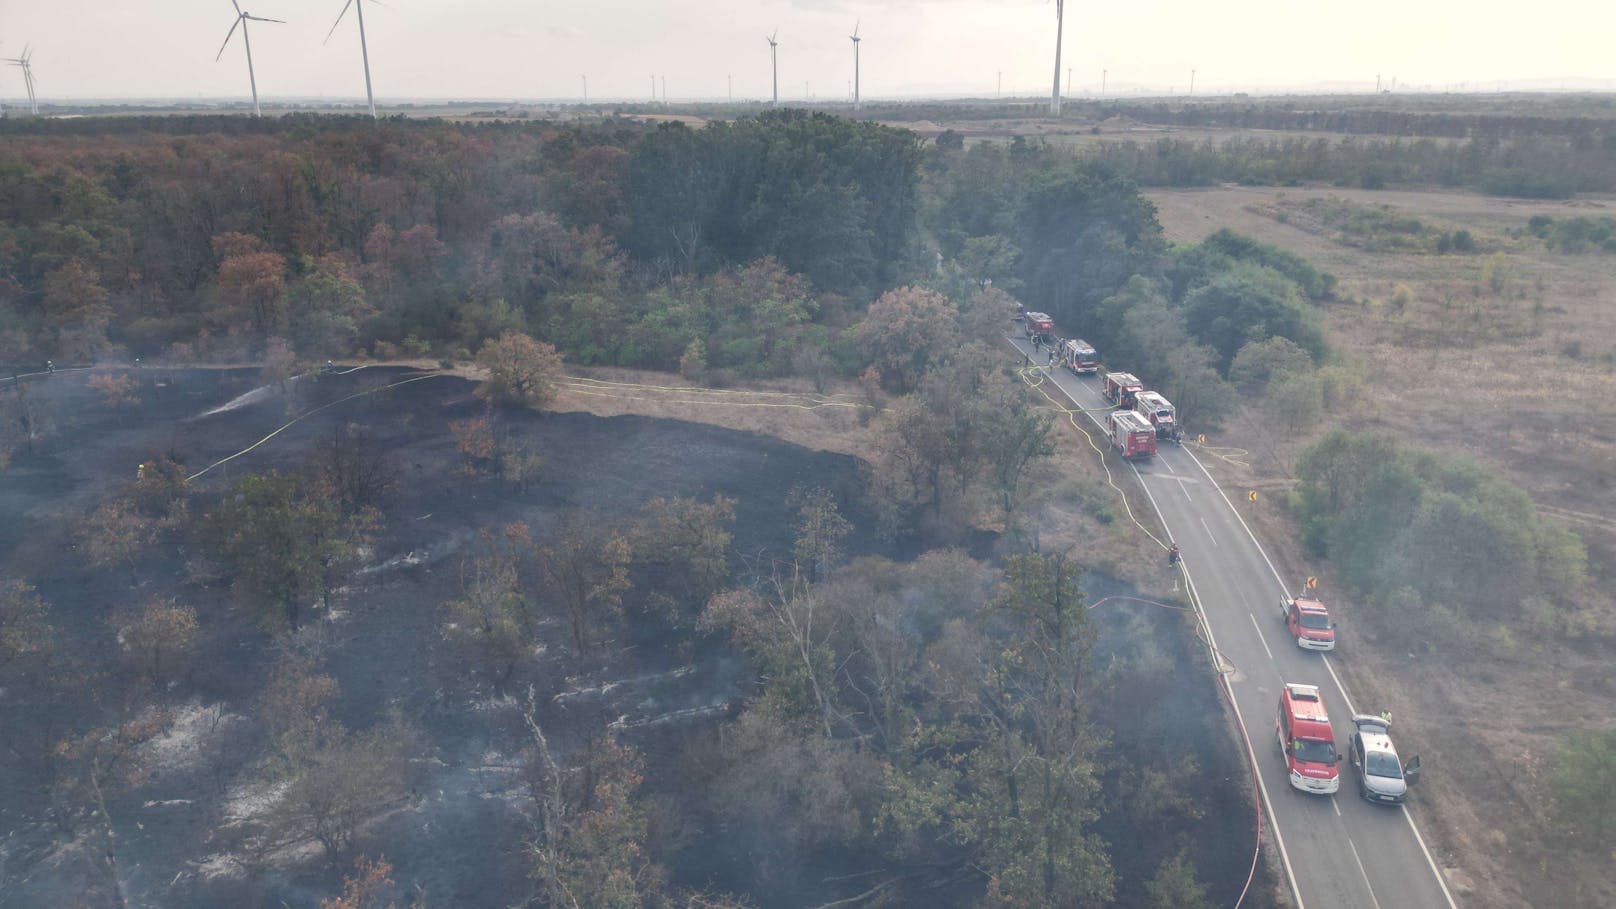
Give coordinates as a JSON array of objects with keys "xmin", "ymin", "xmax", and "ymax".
[{"xmin": 1010, "ymin": 338, "xmax": 1456, "ymax": 909}]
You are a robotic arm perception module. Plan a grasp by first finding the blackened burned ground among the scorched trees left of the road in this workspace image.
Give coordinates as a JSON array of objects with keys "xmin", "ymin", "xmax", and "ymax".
[{"xmin": 0, "ymin": 367, "xmax": 1272, "ymax": 907}]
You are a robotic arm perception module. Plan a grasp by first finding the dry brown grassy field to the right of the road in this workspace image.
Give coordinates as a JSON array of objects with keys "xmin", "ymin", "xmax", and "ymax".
[{"xmin": 1149, "ymin": 180, "xmax": 1616, "ymax": 907}]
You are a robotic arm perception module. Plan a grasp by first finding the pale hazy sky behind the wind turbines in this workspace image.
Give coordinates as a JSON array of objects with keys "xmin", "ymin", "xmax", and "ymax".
[{"xmin": 0, "ymin": 0, "xmax": 1616, "ymax": 100}]
